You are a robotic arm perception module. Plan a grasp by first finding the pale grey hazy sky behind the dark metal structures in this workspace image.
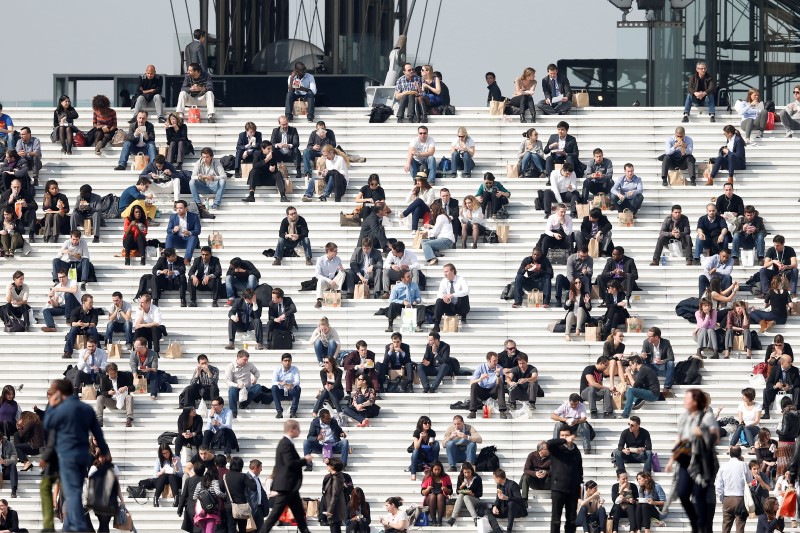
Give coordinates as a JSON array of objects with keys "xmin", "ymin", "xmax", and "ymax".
[{"xmin": 0, "ymin": 0, "xmax": 645, "ymax": 107}]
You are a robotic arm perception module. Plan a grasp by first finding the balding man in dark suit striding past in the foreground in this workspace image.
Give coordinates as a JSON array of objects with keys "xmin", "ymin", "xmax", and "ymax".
[{"xmin": 258, "ymin": 420, "xmax": 311, "ymax": 533}]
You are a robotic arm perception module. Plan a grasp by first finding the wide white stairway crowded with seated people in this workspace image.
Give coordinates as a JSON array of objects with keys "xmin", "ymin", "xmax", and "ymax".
[{"xmin": 0, "ymin": 108, "xmax": 800, "ymax": 533}]
